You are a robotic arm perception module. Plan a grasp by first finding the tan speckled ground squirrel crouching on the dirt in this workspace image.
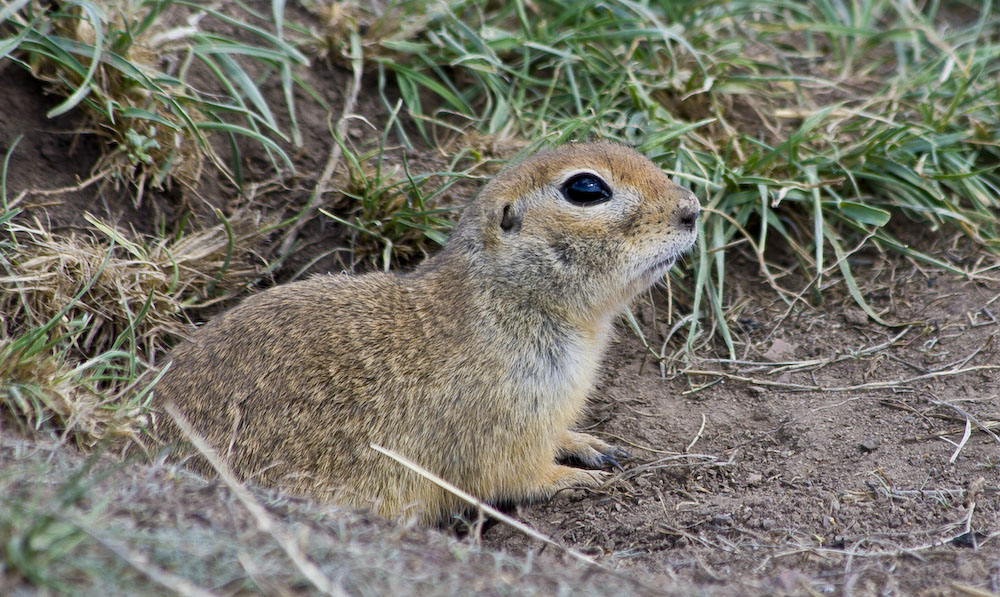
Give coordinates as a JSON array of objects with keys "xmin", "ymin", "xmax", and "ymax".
[{"xmin": 154, "ymin": 143, "xmax": 699, "ymax": 522}]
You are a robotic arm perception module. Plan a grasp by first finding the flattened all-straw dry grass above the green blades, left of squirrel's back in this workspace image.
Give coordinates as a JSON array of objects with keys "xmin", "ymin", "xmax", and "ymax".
[{"xmin": 0, "ymin": 212, "xmax": 267, "ymax": 356}]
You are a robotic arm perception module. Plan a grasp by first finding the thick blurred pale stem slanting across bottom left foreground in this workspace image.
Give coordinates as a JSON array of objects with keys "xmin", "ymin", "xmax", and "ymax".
[{"xmin": 163, "ymin": 404, "xmax": 347, "ymax": 597}]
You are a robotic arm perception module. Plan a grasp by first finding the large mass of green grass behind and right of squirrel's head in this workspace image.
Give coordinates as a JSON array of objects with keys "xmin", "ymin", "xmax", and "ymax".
[{"xmin": 376, "ymin": 0, "xmax": 1000, "ymax": 351}]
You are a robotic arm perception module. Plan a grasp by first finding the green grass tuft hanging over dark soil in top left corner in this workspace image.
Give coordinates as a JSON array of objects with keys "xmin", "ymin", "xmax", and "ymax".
[{"xmin": 0, "ymin": 0, "xmax": 306, "ymax": 196}]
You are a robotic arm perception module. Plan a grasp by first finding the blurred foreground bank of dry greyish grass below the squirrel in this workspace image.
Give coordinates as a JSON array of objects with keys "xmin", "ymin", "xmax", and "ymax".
[{"xmin": 0, "ymin": 439, "xmax": 668, "ymax": 596}]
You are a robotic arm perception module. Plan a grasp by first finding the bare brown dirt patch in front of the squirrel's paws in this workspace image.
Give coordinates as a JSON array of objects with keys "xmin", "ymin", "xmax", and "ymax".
[{"xmin": 487, "ymin": 262, "xmax": 1000, "ymax": 595}]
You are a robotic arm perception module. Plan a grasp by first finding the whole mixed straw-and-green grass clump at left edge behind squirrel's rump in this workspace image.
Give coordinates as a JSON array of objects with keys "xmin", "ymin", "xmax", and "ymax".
[{"xmin": 0, "ymin": 212, "xmax": 267, "ymax": 444}]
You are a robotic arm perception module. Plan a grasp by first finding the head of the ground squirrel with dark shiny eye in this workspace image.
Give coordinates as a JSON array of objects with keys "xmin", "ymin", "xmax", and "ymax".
[{"xmin": 449, "ymin": 143, "xmax": 700, "ymax": 320}]
